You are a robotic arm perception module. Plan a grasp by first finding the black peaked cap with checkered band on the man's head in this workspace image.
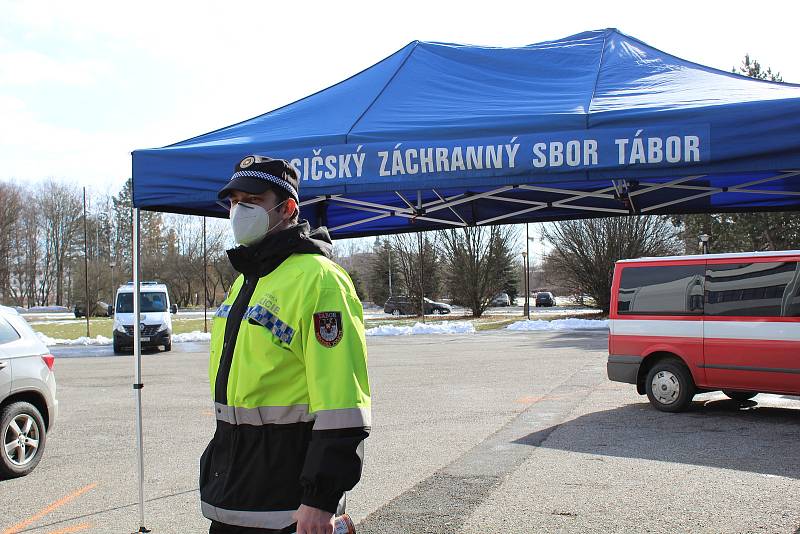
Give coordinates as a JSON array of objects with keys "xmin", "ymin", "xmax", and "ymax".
[{"xmin": 217, "ymin": 155, "xmax": 300, "ymax": 204}]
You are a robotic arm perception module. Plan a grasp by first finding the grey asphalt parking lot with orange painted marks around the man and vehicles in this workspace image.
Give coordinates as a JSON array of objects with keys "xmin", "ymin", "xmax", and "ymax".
[{"xmin": 0, "ymin": 331, "xmax": 800, "ymax": 534}]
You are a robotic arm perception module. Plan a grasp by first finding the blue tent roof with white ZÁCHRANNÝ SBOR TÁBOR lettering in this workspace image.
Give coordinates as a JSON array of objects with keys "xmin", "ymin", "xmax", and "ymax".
[{"xmin": 133, "ymin": 29, "xmax": 800, "ymax": 237}]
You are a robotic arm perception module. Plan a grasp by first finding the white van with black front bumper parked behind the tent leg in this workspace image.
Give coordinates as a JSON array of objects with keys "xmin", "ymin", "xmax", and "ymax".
[{"xmin": 114, "ymin": 282, "xmax": 178, "ymax": 354}]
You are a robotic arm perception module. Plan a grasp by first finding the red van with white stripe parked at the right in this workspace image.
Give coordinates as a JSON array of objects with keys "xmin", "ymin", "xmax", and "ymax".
[{"xmin": 608, "ymin": 250, "xmax": 800, "ymax": 412}]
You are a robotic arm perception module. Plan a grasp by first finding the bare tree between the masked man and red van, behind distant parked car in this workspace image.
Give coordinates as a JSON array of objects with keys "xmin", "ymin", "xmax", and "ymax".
[{"xmin": 440, "ymin": 226, "xmax": 517, "ymax": 317}]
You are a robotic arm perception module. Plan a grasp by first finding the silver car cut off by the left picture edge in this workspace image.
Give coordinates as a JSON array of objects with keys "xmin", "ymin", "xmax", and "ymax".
[{"xmin": 0, "ymin": 306, "xmax": 58, "ymax": 479}]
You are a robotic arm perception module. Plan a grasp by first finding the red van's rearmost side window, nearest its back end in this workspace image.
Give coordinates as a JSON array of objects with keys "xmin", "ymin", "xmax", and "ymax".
[{"xmin": 617, "ymin": 265, "xmax": 705, "ymax": 315}]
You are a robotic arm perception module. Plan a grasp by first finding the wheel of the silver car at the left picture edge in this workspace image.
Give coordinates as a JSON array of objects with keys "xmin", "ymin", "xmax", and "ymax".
[{"xmin": 0, "ymin": 402, "xmax": 47, "ymax": 478}]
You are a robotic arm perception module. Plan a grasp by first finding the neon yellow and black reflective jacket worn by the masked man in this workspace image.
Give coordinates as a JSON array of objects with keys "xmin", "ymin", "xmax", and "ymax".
[{"xmin": 200, "ymin": 248, "xmax": 371, "ymax": 529}]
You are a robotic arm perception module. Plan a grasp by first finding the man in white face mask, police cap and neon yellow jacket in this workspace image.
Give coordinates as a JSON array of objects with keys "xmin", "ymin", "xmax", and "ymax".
[{"xmin": 200, "ymin": 156, "xmax": 370, "ymax": 534}]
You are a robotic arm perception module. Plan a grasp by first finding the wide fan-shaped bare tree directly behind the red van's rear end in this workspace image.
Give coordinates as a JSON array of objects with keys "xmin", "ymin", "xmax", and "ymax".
[{"xmin": 542, "ymin": 216, "xmax": 680, "ymax": 312}]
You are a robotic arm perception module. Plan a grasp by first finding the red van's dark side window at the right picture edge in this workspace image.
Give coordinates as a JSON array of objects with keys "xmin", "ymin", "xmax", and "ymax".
[{"xmin": 706, "ymin": 261, "xmax": 800, "ymax": 317}]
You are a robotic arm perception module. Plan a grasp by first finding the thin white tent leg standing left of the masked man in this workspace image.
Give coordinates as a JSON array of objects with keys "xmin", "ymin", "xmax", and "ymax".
[{"xmin": 131, "ymin": 208, "xmax": 150, "ymax": 532}]
